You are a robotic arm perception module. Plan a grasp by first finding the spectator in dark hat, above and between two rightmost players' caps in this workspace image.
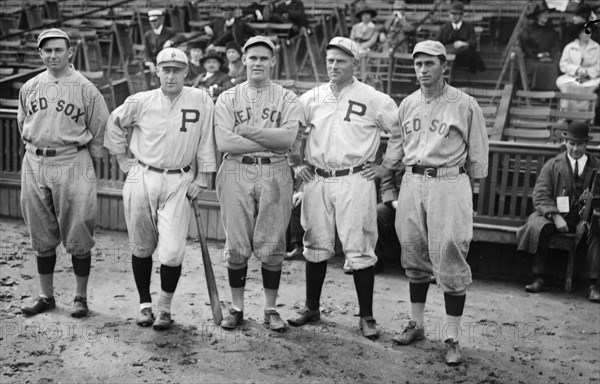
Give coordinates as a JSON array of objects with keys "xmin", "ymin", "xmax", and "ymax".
[{"xmin": 380, "ymin": 0, "xmax": 415, "ymax": 52}]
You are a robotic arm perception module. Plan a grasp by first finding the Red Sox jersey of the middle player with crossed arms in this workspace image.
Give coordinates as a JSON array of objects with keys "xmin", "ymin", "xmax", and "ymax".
[{"xmin": 215, "ymin": 81, "xmax": 304, "ymax": 157}]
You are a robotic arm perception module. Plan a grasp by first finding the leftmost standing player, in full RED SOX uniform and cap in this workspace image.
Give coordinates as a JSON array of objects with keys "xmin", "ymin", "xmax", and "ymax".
[{"xmin": 17, "ymin": 28, "xmax": 108, "ymax": 317}]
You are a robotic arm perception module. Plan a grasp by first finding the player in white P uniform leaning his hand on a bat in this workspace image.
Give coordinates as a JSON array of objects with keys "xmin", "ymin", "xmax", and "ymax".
[{"xmin": 104, "ymin": 48, "xmax": 216, "ymax": 330}]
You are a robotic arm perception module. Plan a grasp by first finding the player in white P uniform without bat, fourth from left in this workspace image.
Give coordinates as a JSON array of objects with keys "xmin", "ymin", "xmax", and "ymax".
[{"xmin": 288, "ymin": 37, "xmax": 400, "ymax": 339}]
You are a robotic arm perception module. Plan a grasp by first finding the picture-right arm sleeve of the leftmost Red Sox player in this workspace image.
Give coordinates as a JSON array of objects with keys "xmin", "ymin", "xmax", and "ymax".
[{"xmin": 82, "ymin": 83, "xmax": 109, "ymax": 157}]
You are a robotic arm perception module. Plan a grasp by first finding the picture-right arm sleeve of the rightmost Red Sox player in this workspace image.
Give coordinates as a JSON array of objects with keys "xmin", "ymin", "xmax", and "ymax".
[{"xmin": 465, "ymin": 99, "xmax": 489, "ymax": 179}]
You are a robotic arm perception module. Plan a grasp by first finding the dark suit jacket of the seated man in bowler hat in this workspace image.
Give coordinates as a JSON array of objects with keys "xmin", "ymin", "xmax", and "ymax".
[{"xmin": 517, "ymin": 152, "xmax": 600, "ymax": 253}]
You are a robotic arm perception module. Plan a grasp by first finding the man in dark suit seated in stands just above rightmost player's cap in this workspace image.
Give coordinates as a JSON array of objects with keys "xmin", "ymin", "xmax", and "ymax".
[{"xmin": 436, "ymin": 1, "xmax": 485, "ymax": 73}]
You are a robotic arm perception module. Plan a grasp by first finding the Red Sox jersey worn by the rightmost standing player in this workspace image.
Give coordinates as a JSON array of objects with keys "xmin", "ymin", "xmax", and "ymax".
[{"xmin": 383, "ymin": 85, "xmax": 489, "ymax": 178}]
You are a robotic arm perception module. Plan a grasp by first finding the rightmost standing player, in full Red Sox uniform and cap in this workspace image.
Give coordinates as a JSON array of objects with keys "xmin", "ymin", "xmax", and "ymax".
[{"xmin": 378, "ymin": 40, "xmax": 489, "ymax": 365}]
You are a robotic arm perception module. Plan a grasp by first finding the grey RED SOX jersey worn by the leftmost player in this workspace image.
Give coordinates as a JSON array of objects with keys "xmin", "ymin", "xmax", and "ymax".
[{"xmin": 17, "ymin": 65, "xmax": 108, "ymax": 157}]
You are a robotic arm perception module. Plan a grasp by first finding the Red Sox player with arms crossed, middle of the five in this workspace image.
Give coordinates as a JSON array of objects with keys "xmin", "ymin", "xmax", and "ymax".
[{"xmin": 215, "ymin": 36, "xmax": 303, "ymax": 332}]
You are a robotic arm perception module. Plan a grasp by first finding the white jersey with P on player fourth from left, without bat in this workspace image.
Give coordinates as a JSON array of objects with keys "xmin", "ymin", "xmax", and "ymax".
[{"xmin": 300, "ymin": 78, "xmax": 400, "ymax": 169}]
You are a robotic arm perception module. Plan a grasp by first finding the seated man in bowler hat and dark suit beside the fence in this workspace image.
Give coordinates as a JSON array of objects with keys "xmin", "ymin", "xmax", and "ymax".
[{"xmin": 517, "ymin": 122, "xmax": 600, "ymax": 302}]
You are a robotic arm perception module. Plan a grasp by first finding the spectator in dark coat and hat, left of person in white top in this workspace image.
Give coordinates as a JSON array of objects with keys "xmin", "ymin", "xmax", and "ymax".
[{"xmin": 519, "ymin": 2, "xmax": 559, "ymax": 91}]
